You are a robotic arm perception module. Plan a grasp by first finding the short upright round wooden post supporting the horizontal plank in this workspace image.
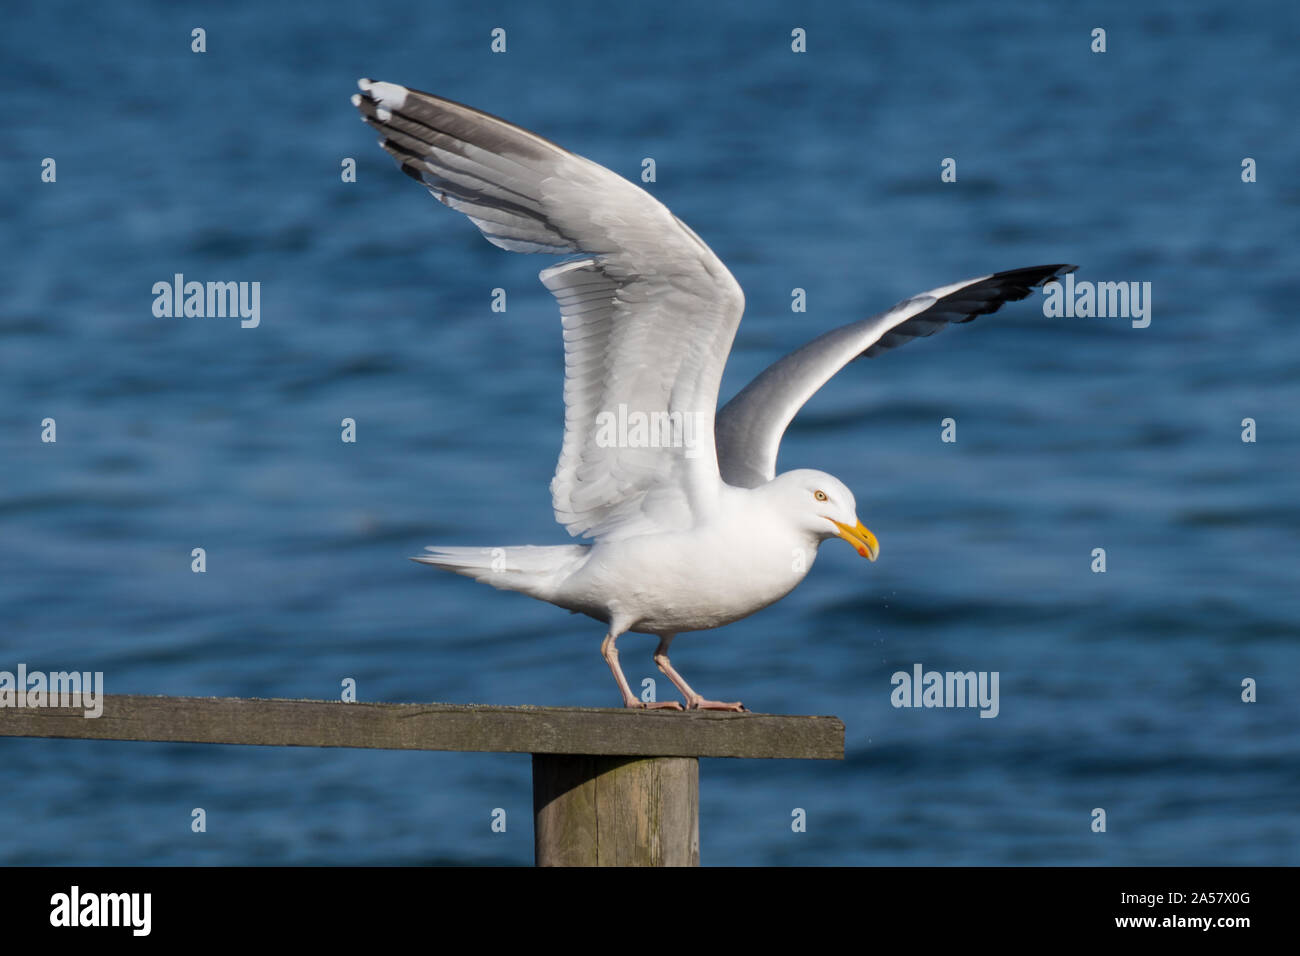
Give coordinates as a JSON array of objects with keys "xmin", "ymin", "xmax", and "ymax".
[{"xmin": 533, "ymin": 753, "xmax": 699, "ymax": 866}]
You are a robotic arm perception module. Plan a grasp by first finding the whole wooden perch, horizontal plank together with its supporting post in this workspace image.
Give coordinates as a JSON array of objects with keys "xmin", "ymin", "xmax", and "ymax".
[{"xmin": 0, "ymin": 695, "xmax": 844, "ymax": 866}]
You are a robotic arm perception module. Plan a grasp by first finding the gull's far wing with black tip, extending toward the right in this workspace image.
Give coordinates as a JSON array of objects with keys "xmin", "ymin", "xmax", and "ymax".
[{"xmin": 716, "ymin": 265, "xmax": 1076, "ymax": 488}]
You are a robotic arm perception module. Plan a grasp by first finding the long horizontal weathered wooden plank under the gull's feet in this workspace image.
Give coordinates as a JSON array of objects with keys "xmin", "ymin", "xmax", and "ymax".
[{"xmin": 0, "ymin": 695, "xmax": 844, "ymax": 760}]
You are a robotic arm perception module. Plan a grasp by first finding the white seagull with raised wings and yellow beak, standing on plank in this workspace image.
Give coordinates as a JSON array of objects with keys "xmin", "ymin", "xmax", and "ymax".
[{"xmin": 352, "ymin": 79, "xmax": 1075, "ymax": 711}]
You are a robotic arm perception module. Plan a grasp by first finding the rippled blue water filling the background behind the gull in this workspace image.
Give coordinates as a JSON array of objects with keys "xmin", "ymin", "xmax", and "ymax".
[{"xmin": 0, "ymin": 0, "xmax": 1300, "ymax": 865}]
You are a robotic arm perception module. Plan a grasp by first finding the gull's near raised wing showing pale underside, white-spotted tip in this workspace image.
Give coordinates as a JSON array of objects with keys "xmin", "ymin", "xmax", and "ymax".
[{"xmin": 352, "ymin": 79, "xmax": 745, "ymax": 536}]
